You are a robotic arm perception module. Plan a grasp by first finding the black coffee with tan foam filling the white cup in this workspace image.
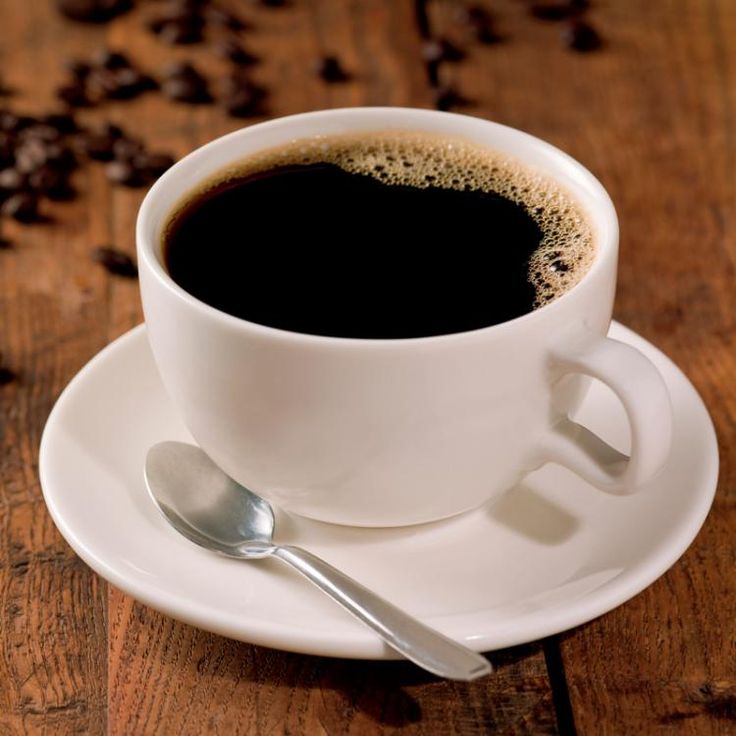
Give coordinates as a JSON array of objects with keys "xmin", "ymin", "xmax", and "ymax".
[{"xmin": 163, "ymin": 131, "xmax": 595, "ymax": 338}]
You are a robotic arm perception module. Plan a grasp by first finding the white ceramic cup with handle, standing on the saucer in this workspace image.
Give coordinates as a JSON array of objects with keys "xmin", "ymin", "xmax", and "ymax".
[{"xmin": 137, "ymin": 108, "xmax": 671, "ymax": 526}]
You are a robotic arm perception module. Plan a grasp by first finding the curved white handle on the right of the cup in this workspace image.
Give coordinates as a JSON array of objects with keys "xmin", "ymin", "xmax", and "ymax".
[{"xmin": 540, "ymin": 336, "xmax": 672, "ymax": 495}]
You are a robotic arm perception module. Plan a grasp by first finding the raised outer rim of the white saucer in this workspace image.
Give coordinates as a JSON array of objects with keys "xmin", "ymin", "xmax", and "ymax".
[{"xmin": 39, "ymin": 322, "xmax": 719, "ymax": 659}]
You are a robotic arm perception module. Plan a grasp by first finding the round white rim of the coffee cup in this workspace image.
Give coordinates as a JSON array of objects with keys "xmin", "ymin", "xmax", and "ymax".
[{"xmin": 136, "ymin": 106, "xmax": 619, "ymax": 347}]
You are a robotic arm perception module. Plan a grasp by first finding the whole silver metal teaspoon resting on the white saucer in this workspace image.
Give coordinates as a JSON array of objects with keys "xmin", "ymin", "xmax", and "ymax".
[{"xmin": 145, "ymin": 442, "xmax": 491, "ymax": 680}]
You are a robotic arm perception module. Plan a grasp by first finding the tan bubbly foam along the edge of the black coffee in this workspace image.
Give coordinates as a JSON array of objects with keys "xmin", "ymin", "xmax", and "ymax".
[{"xmin": 175, "ymin": 130, "xmax": 596, "ymax": 309}]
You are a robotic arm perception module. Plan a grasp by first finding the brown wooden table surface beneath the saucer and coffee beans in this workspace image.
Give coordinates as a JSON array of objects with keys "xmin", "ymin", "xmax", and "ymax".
[{"xmin": 0, "ymin": 0, "xmax": 736, "ymax": 736}]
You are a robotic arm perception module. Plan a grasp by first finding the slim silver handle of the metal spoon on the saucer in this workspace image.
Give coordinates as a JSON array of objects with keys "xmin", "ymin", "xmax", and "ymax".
[{"xmin": 272, "ymin": 545, "xmax": 492, "ymax": 680}]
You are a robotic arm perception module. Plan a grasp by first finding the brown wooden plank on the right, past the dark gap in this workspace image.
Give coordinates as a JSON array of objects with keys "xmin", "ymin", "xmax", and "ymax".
[{"xmin": 432, "ymin": 0, "xmax": 736, "ymax": 734}]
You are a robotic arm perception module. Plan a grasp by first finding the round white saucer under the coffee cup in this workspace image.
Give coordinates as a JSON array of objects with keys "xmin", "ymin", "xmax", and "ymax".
[{"xmin": 40, "ymin": 324, "xmax": 718, "ymax": 659}]
